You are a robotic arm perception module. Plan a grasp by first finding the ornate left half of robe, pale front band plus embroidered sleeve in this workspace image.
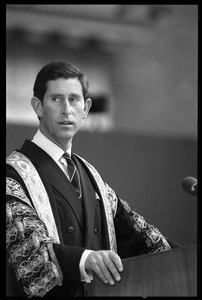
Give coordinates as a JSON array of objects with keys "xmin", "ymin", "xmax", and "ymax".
[{"xmin": 6, "ymin": 151, "xmax": 63, "ymax": 298}]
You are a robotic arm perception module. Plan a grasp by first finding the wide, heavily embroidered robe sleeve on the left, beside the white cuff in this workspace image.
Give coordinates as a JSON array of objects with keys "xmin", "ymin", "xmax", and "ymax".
[{"xmin": 6, "ymin": 177, "xmax": 63, "ymax": 298}]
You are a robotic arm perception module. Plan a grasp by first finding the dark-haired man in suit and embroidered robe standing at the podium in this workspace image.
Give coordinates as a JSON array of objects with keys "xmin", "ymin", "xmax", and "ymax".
[{"xmin": 6, "ymin": 62, "xmax": 171, "ymax": 297}]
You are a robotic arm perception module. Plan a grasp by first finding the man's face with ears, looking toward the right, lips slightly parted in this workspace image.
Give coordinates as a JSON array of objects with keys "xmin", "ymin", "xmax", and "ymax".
[{"xmin": 32, "ymin": 78, "xmax": 91, "ymax": 150}]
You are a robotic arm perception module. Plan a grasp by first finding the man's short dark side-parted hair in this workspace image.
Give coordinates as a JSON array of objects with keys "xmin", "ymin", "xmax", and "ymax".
[{"xmin": 33, "ymin": 61, "xmax": 89, "ymax": 102}]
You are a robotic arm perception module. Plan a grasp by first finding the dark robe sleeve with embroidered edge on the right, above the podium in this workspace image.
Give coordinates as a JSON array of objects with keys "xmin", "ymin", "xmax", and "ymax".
[{"xmin": 106, "ymin": 184, "xmax": 171, "ymax": 258}]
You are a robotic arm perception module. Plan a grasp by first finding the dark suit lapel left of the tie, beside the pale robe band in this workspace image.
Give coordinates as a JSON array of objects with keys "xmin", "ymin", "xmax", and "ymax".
[{"xmin": 21, "ymin": 140, "xmax": 82, "ymax": 228}]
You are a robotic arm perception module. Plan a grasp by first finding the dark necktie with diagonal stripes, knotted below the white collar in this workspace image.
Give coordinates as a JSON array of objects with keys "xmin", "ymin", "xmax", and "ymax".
[{"xmin": 63, "ymin": 152, "xmax": 82, "ymax": 199}]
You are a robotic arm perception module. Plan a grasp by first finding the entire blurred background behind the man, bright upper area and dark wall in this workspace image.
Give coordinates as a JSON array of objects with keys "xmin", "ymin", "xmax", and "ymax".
[{"xmin": 6, "ymin": 4, "xmax": 198, "ymax": 245}]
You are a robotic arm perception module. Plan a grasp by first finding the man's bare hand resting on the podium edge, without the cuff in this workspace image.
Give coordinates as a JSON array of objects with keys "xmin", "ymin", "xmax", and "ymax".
[{"xmin": 85, "ymin": 250, "xmax": 123, "ymax": 285}]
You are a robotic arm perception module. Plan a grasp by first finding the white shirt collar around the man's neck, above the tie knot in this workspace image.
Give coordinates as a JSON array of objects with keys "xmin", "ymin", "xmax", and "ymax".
[{"xmin": 32, "ymin": 129, "xmax": 71, "ymax": 162}]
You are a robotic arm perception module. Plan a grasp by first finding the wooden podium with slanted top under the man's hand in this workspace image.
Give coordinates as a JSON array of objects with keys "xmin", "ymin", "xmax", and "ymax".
[{"xmin": 91, "ymin": 245, "xmax": 197, "ymax": 298}]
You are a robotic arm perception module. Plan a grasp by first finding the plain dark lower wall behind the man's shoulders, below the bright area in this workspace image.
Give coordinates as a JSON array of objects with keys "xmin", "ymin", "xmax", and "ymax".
[{"xmin": 7, "ymin": 125, "xmax": 197, "ymax": 245}]
